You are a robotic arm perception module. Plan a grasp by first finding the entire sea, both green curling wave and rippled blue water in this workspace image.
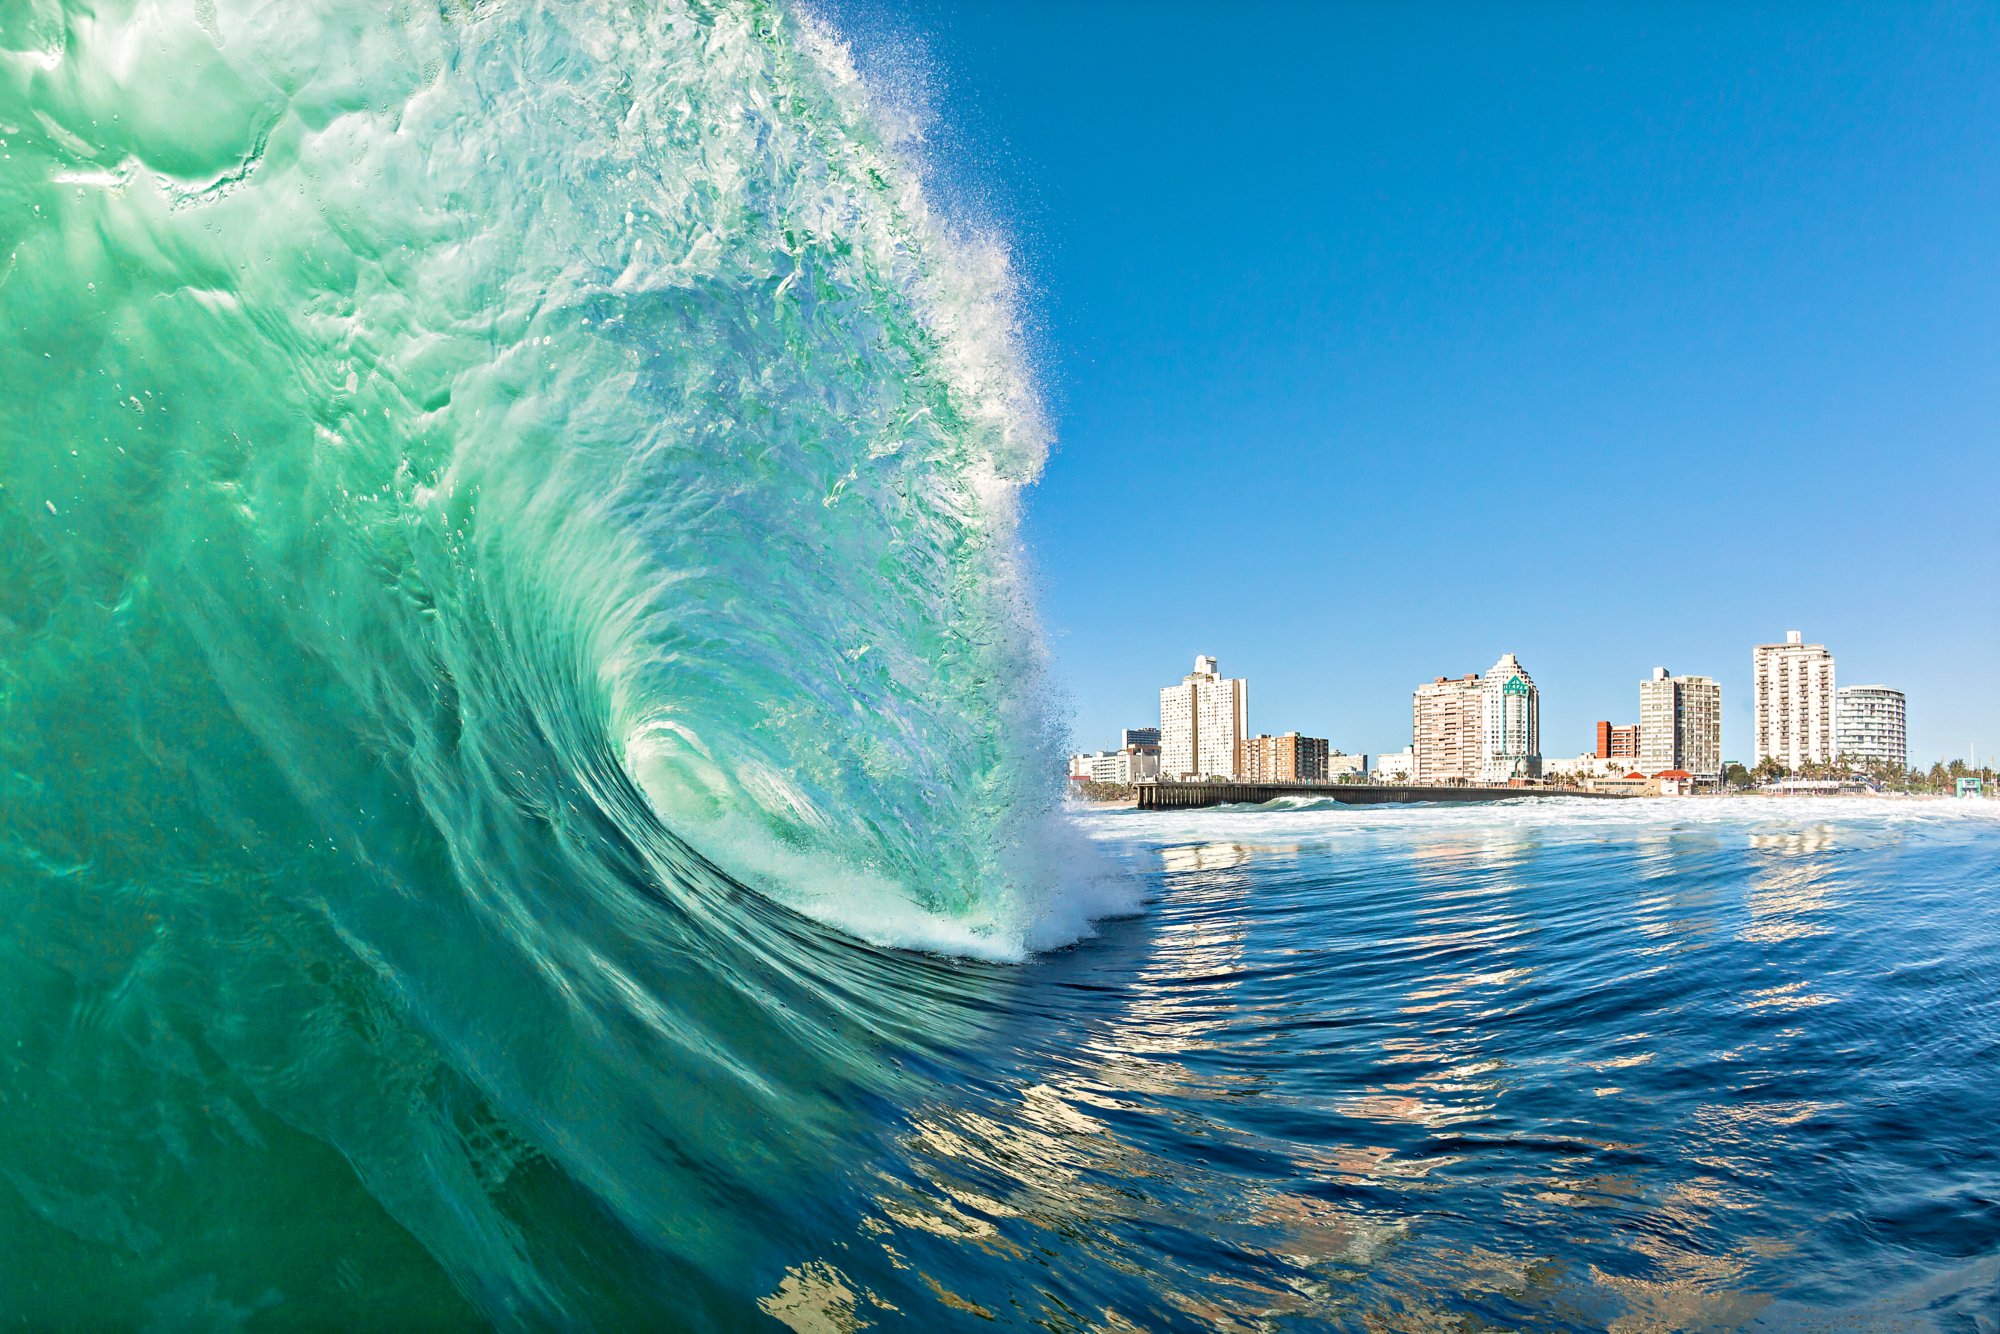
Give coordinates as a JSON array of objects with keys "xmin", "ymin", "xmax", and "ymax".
[{"xmin": 0, "ymin": 0, "xmax": 2000, "ymax": 1330}]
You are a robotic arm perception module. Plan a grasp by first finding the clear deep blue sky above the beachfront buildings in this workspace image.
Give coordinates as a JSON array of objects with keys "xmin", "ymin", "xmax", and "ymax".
[{"xmin": 832, "ymin": 0, "xmax": 2000, "ymax": 762}]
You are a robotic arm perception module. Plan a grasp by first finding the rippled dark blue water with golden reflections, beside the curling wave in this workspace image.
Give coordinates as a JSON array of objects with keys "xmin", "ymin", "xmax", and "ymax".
[{"xmin": 796, "ymin": 800, "xmax": 2000, "ymax": 1330}]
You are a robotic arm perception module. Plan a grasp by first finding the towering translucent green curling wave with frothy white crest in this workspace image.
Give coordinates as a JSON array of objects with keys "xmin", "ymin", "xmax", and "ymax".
[{"xmin": 0, "ymin": 0, "xmax": 1128, "ymax": 1324}]
